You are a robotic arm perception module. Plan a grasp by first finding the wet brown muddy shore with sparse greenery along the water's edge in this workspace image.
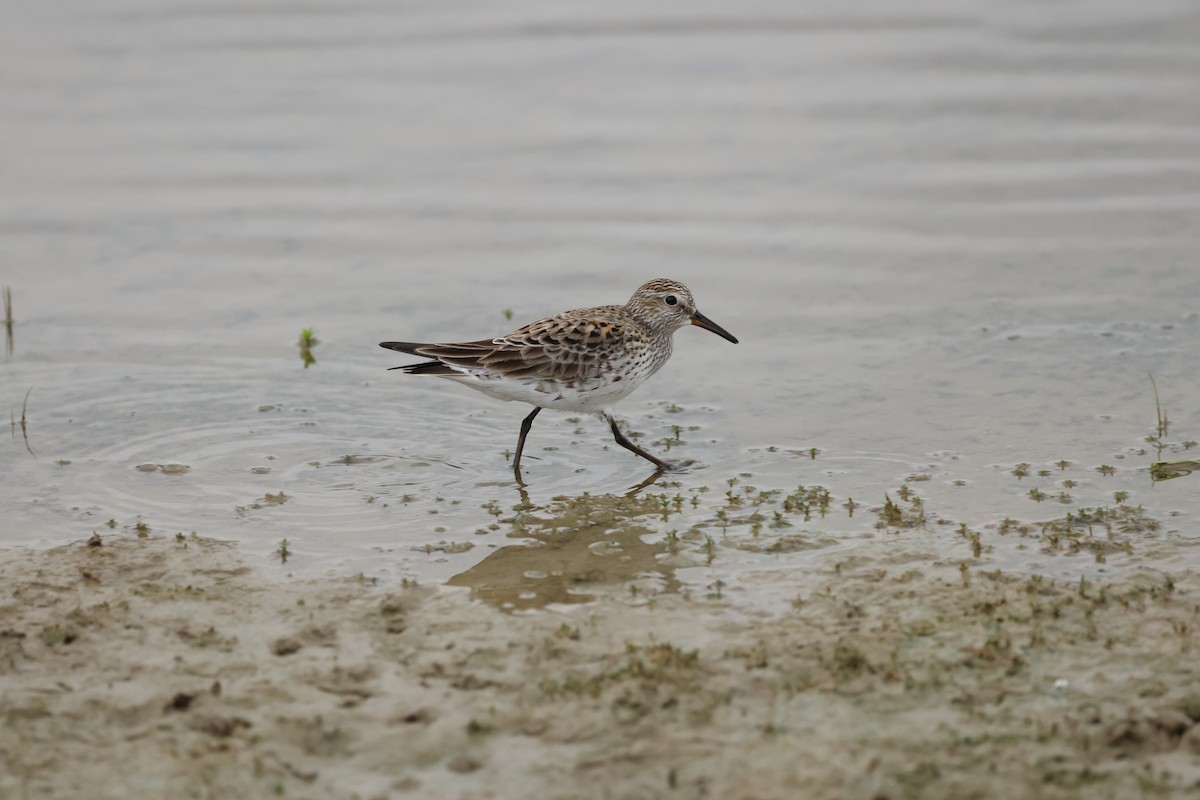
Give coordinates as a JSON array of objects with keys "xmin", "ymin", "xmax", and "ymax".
[{"xmin": 0, "ymin": 535, "xmax": 1200, "ymax": 798}]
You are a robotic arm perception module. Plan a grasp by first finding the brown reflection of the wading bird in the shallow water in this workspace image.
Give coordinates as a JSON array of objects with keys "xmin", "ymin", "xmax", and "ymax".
[{"xmin": 446, "ymin": 474, "xmax": 678, "ymax": 610}]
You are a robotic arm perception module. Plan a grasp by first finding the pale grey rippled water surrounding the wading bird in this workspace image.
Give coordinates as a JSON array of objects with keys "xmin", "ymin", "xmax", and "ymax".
[{"xmin": 0, "ymin": 0, "xmax": 1200, "ymax": 607}]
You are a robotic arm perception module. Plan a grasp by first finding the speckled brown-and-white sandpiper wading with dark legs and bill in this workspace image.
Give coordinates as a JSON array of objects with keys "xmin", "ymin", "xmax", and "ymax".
[{"xmin": 379, "ymin": 278, "xmax": 738, "ymax": 481}]
